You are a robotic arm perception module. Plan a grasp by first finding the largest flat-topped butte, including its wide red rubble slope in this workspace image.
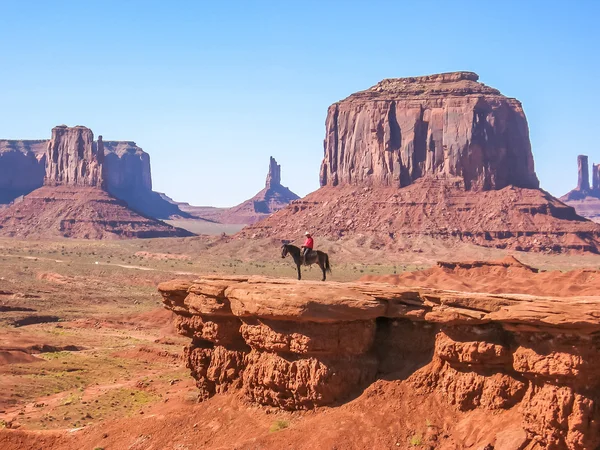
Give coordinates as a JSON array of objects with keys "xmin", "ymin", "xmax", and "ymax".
[{"xmin": 238, "ymin": 72, "xmax": 600, "ymax": 252}]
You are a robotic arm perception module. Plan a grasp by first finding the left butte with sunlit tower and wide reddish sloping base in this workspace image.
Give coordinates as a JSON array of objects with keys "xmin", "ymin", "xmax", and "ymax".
[{"xmin": 0, "ymin": 125, "xmax": 191, "ymax": 239}]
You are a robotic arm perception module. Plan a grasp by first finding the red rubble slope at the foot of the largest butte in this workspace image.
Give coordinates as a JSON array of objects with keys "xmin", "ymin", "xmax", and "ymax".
[{"xmin": 237, "ymin": 183, "xmax": 600, "ymax": 252}]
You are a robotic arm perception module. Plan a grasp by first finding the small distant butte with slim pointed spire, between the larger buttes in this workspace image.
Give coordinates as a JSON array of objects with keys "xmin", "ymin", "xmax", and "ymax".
[{"xmin": 216, "ymin": 156, "xmax": 300, "ymax": 224}]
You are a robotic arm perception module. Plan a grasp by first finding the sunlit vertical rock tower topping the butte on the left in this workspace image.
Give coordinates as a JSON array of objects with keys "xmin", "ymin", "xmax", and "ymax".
[{"xmin": 44, "ymin": 125, "xmax": 104, "ymax": 188}]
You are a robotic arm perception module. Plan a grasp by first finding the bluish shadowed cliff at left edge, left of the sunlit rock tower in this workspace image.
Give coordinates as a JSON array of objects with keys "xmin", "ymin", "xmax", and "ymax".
[{"xmin": 0, "ymin": 139, "xmax": 48, "ymax": 204}]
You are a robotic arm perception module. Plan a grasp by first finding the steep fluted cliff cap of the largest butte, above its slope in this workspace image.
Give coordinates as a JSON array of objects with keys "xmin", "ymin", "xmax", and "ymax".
[{"xmin": 320, "ymin": 72, "xmax": 539, "ymax": 190}]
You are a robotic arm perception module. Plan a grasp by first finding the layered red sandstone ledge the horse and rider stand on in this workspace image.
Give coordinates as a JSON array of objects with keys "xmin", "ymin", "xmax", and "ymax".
[{"xmin": 159, "ymin": 277, "xmax": 600, "ymax": 450}]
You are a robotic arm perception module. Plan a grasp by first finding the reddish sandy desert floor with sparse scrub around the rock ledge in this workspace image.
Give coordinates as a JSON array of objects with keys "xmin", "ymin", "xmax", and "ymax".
[{"xmin": 0, "ymin": 237, "xmax": 600, "ymax": 449}]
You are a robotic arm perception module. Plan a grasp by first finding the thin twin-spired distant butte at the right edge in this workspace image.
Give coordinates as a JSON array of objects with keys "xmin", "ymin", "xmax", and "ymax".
[{"xmin": 560, "ymin": 155, "xmax": 600, "ymax": 223}]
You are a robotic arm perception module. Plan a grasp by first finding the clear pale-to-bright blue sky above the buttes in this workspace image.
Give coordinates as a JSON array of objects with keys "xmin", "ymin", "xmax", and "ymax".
[{"xmin": 0, "ymin": 0, "xmax": 600, "ymax": 206}]
